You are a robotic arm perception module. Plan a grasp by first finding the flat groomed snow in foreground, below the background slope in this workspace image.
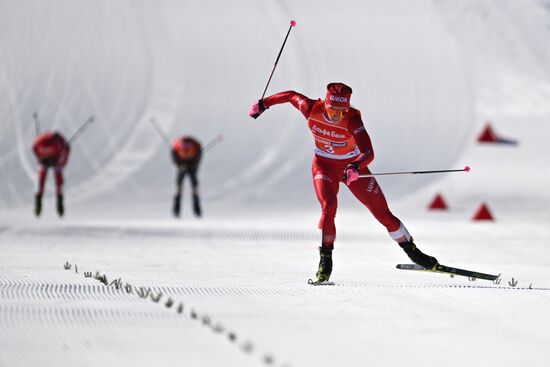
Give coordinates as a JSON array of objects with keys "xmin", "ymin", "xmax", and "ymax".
[{"xmin": 0, "ymin": 212, "xmax": 550, "ymax": 366}]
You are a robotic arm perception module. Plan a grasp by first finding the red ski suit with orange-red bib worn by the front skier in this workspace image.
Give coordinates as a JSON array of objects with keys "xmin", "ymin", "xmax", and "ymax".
[{"xmin": 263, "ymin": 91, "xmax": 411, "ymax": 246}]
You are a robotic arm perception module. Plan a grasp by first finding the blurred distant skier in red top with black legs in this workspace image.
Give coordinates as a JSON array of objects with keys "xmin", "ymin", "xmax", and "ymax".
[{"xmin": 172, "ymin": 136, "xmax": 202, "ymax": 217}]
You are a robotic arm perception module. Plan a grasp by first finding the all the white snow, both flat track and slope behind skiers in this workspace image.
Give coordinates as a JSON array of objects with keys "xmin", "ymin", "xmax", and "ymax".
[{"xmin": 0, "ymin": 0, "xmax": 550, "ymax": 367}]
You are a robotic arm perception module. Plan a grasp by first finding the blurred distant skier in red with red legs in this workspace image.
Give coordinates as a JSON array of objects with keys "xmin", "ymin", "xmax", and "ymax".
[{"xmin": 32, "ymin": 131, "xmax": 70, "ymax": 217}]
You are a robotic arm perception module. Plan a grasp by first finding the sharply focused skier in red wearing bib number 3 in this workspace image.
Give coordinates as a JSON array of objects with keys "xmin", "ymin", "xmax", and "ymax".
[{"xmin": 249, "ymin": 83, "xmax": 438, "ymax": 281}]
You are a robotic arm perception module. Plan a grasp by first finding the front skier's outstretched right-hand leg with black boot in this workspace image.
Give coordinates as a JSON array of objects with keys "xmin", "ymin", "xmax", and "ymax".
[{"xmin": 349, "ymin": 177, "xmax": 438, "ymax": 269}]
